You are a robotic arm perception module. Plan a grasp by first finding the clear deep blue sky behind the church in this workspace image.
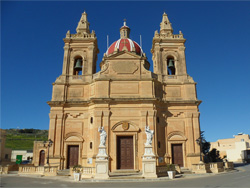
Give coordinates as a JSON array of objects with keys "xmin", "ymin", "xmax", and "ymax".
[{"xmin": 1, "ymin": 1, "xmax": 250, "ymax": 141}]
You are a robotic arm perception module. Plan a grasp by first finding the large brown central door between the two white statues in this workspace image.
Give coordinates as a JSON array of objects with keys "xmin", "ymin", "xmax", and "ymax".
[{"xmin": 117, "ymin": 136, "xmax": 134, "ymax": 169}]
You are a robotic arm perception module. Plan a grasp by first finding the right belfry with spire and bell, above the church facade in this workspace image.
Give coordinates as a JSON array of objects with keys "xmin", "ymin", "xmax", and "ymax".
[{"xmin": 151, "ymin": 12, "xmax": 187, "ymax": 82}]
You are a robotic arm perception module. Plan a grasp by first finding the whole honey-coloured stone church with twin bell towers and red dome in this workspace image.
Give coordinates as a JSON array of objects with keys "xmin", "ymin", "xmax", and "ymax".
[{"xmin": 33, "ymin": 12, "xmax": 201, "ymax": 172}]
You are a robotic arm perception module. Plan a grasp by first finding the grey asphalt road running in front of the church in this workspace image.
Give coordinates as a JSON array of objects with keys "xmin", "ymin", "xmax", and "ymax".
[{"xmin": 1, "ymin": 164, "xmax": 250, "ymax": 188}]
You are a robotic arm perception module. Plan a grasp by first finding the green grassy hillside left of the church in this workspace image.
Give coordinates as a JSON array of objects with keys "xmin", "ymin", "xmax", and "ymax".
[{"xmin": 5, "ymin": 129, "xmax": 48, "ymax": 150}]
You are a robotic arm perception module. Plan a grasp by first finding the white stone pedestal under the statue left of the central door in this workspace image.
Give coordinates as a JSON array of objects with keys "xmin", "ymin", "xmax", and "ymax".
[{"xmin": 95, "ymin": 146, "xmax": 109, "ymax": 179}]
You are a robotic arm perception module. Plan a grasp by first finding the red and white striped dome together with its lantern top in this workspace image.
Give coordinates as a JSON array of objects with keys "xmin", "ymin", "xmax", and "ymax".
[{"xmin": 106, "ymin": 20, "xmax": 143, "ymax": 56}]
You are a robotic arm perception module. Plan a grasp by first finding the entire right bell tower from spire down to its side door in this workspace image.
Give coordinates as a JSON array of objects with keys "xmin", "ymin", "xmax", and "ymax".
[{"xmin": 151, "ymin": 13, "xmax": 201, "ymax": 166}]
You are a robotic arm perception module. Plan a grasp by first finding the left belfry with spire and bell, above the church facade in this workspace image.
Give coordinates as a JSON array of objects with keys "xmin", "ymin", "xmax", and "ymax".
[{"xmin": 59, "ymin": 12, "xmax": 99, "ymax": 83}]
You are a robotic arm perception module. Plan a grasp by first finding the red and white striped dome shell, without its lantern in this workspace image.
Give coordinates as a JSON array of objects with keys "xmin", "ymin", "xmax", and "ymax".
[{"xmin": 106, "ymin": 38, "xmax": 143, "ymax": 56}]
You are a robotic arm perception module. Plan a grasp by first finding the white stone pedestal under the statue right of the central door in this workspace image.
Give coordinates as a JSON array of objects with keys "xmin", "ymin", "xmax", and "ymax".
[{"xmin": 142, "ymin": 146, "xmax": 157, "ymax": 179}]
